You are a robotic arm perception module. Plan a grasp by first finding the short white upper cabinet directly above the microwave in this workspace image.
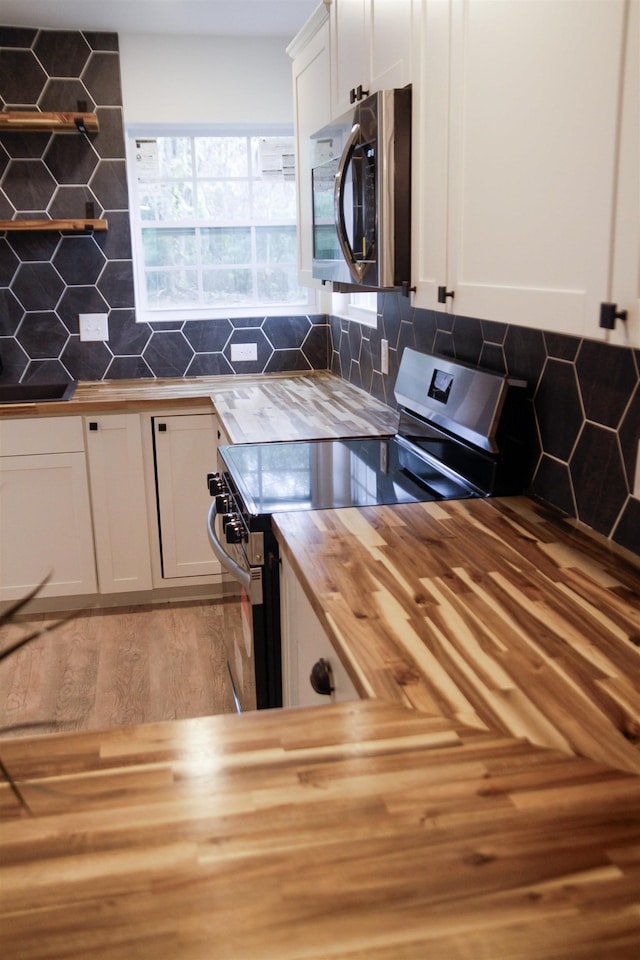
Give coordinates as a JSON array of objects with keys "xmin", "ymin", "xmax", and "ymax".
[{"xmin": 331, "ymin": 0, "xmax": 414, "ymax": 117}]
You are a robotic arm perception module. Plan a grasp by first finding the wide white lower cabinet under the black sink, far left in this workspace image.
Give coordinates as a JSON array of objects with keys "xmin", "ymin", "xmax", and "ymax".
[{"xmin": 0, "ymin": 417, "xmax": 96, "ymax": 601}]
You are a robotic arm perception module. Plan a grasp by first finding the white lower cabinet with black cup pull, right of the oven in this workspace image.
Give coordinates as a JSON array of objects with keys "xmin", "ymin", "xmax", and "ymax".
[{"xmin": 280, "ymin": 557, "xmax": 360, "ymax": 707}]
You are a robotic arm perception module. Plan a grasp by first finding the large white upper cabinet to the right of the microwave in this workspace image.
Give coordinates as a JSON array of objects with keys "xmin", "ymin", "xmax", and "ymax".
[{"xmin": 413, "ymin": 0, "xmax": 640, "ymax": 344}]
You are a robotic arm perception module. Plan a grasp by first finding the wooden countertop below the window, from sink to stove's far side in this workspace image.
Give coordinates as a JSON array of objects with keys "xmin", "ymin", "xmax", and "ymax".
[{"xmin": 0, "ymin": 371, "xmax": 398, "ymax": 443}]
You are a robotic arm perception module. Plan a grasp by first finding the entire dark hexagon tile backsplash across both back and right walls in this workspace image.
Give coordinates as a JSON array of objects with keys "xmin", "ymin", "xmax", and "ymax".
[{"xmin": 0, "ymin": 26, "xmax": 640, "ymax": 555}]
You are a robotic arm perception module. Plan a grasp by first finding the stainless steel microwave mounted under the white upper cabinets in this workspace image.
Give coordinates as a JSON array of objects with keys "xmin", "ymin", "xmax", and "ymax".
[{"xmin": 311, "ymin": 86, "xmax": 411, "ymax": 290}]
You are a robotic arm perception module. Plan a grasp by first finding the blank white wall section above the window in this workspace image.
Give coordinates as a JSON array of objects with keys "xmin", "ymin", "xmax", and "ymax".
[{"xmin": 119, "ymin": 33, "xmax": 293, "ymax": 126}]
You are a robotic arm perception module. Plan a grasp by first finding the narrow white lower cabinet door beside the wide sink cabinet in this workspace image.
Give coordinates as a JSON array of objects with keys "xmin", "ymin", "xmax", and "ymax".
[{"xmin": 85, "ymin": 413, "xmax": 152, "ymax": 593}]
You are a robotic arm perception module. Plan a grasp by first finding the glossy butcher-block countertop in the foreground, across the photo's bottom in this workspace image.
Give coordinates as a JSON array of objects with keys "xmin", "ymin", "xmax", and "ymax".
[{"xmin": 0, "ymin": 701, "xmax": 640, "ymax": 960}]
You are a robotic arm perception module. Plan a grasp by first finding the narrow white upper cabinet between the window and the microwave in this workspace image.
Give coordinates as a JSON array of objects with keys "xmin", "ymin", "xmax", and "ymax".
[{"xmin": 292, "ymin": 9, "xmax": 331, "ymax": 287}]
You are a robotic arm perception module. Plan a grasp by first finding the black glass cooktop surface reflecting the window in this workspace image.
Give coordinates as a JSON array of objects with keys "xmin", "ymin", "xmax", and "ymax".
[{"xmin": 219, "ymin": 437, "xmax": 477, "ymax": 516}]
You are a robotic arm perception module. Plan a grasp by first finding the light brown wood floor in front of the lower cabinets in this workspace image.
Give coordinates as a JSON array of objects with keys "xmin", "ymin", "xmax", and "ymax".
[{"xmin": 0, "ymin": 600, "xmax": 242, "ymax": 738}]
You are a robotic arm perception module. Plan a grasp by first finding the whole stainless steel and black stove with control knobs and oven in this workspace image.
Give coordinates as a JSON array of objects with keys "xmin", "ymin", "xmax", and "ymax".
[{"xmin": 208, "ymin": 349, "xmax": 529, "ymax": 709}]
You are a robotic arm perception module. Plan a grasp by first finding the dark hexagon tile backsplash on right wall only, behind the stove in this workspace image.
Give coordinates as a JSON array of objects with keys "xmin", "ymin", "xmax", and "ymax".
[{"xmin": 330, "ymin": 293, "xmax": 640, "ymax": 554}]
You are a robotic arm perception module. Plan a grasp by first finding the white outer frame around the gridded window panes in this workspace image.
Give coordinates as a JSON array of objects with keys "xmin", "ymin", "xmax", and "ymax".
[{"xmin": 125, "ymin": 123, "xmax": 320, "ymax": 323}]
